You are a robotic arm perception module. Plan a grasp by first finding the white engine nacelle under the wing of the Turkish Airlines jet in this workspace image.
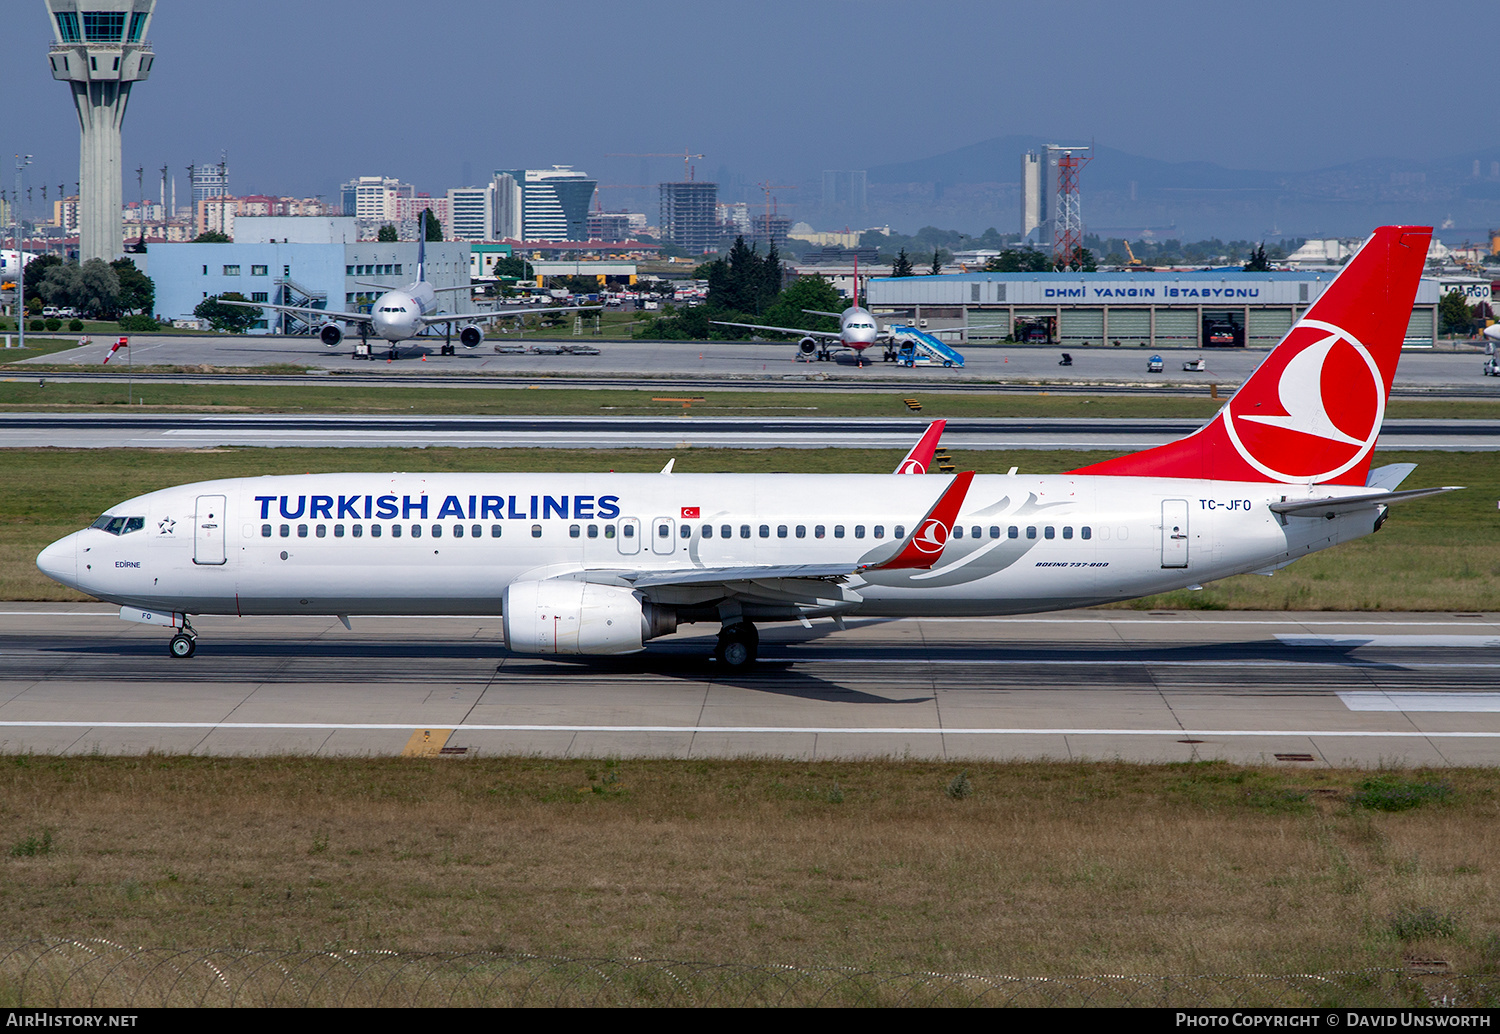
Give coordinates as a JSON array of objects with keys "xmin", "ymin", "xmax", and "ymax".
[{"xmin": 503, "ymin": 579, "xmax": 677, "ymax": 654}]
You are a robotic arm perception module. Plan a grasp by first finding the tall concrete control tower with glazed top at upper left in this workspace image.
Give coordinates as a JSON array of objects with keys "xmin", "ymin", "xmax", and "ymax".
[{"xmin": 47, "ymin": 0, "xmax": 156, "ymax": 263}]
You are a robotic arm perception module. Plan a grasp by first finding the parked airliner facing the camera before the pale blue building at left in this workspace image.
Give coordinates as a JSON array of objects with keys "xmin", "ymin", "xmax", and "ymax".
[{"xmin": 225, "ymin": 240, "xmax": 600, "ymax": 359}]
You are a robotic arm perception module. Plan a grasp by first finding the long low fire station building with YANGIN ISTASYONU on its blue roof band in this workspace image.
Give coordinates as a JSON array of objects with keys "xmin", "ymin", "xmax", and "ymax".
[{"xmin": 867, "ymin": 270, "xmax": 1458, "ymax": 348}]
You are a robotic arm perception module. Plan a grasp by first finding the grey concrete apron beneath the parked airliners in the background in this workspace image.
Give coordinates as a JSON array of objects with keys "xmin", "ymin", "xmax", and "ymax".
[{"xmin": 11, "ymin": 335, "xmax": 1500, "ymax": 395}]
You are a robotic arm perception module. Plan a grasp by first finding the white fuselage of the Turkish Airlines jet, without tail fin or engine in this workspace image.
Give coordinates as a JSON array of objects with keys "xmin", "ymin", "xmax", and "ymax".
[{"xmin": 38, "ymin": 474, "xmax": 1379, "ymax": 620}]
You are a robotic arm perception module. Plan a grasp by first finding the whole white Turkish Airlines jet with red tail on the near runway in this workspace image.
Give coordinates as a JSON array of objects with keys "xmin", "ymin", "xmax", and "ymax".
[{"xmin": 38, "ymin": 227, "xmax": 1449, "ymax": 668}]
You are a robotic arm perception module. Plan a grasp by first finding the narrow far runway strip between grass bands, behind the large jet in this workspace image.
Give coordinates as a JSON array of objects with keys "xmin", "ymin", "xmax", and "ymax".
[{"xmin": 0, "ymin": 413, "xmax": 1500, "ymax": 452}]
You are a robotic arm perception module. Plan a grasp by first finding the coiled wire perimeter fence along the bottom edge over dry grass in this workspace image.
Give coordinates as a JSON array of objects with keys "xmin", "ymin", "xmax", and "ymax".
[{"xmin": 0, "ymin": 939, "xmax": 1500, "ymax": 1008}]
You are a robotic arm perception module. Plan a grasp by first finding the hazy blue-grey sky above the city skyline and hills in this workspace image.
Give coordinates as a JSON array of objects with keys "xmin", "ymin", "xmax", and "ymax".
[{"xmin": 0, "ymin": 0, "xmax": 1494, "ymax": 207}]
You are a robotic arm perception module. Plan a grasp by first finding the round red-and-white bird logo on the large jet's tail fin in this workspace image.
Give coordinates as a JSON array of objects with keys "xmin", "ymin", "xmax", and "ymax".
[{"xmin": 1224, "ymin": 320, "xmax": 1386, "ymax": 482}]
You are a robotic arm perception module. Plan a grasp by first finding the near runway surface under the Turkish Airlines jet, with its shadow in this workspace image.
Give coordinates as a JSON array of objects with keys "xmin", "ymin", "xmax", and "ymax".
[{"xmin": 0, "ymin": 603, "xmax": 1500, "ymax": 767}]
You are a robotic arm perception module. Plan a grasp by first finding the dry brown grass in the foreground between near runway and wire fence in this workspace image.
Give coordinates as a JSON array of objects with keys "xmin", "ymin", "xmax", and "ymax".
[{"xmin": 0, "ymin": 755, "xmax": 1500, "ymax": 975}]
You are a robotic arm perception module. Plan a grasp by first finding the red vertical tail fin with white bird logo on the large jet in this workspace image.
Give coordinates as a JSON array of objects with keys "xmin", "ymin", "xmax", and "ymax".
[{"xmin": 1073, "ymin": 227, "xmax": 1433, "ymax": 485}]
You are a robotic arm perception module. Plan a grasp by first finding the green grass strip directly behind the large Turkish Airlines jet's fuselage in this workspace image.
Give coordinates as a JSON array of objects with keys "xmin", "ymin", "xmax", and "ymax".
[{"xmin": 0, "ymin": 449, "xmax": 1500, "ymax": 611}]
